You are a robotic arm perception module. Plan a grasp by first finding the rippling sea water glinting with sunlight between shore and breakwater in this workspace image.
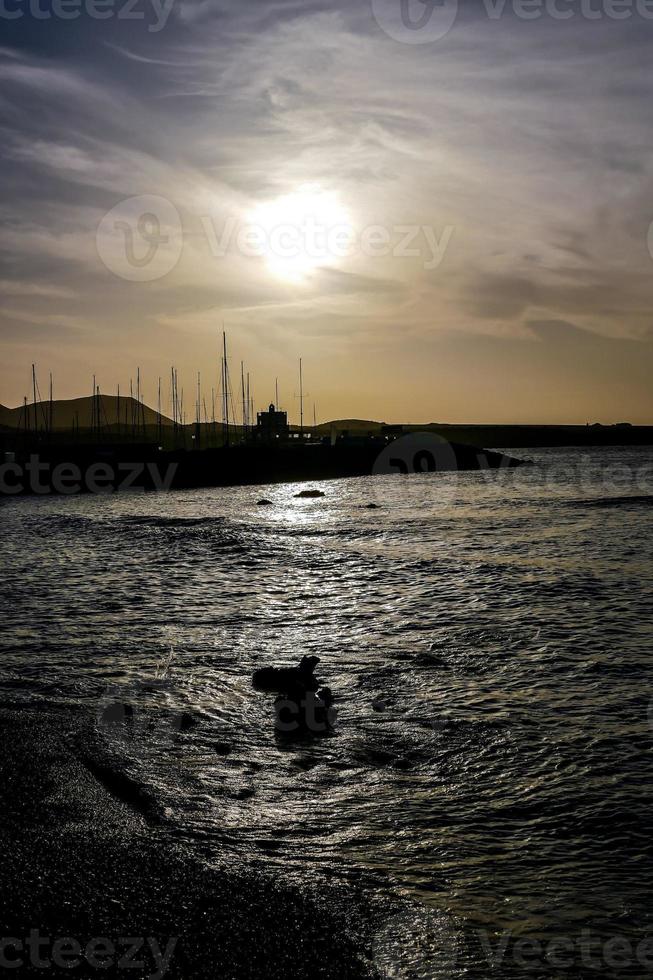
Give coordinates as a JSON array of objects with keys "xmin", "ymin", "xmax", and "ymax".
[{"xmin": 0, "ymin": 448, "xmax": 653, "ymax": 978}]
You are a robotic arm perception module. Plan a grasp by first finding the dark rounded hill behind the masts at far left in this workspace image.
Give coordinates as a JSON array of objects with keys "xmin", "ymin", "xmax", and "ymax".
[{"xmin": 0, "ymin": 395, "xmax": 174, "ymax": 431}]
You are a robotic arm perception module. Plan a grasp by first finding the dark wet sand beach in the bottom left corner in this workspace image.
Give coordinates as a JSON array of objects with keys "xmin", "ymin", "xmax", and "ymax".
[{"xmin": 0, "ymin": 710, "xmax": 374, "ymax": 980}]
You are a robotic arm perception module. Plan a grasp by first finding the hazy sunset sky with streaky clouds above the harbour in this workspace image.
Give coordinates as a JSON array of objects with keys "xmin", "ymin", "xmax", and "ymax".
[{"xmin": 0, "ymin": 0, "xmax": 653, "ymax": 424}]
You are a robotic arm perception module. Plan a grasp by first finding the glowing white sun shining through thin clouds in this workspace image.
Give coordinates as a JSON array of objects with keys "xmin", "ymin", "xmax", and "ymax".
[{"xmin": 248, "ymin": 184, "xmax": 354, "ymax": 283}]
